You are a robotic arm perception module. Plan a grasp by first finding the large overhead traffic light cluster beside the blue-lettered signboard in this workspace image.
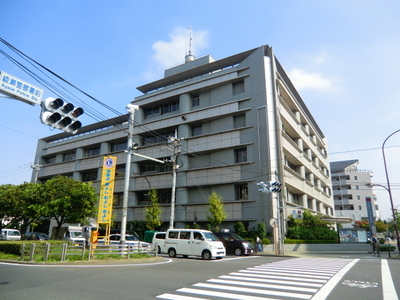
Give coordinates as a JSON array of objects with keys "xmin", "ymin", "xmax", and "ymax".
[{"xmin": 40, "ymin": 97, "xmax": 83, "ymax": 134}]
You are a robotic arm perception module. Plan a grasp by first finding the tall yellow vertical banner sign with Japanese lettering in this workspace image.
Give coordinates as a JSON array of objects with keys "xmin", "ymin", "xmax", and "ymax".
[{"xmin": 97, "ymin": 156, "xmax": 117, "ymax": 224}]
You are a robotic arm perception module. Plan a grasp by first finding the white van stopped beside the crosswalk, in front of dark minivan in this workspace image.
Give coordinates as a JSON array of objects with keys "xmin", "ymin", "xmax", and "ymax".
[{"xmin": 165, "ymin": 228, "xmax": 225, "ymax": 259}]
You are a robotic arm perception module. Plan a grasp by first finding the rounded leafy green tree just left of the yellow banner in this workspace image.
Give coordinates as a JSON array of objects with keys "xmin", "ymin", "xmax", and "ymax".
[{"xmin": 43, "ymin": 176, "xmax": 97, "ymax": 237}]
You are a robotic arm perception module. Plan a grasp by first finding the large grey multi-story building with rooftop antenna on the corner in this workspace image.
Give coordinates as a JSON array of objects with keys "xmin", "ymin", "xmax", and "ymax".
[{"xmin": 33, "ymin": 45, "xmax": 333, "ymax": 237}]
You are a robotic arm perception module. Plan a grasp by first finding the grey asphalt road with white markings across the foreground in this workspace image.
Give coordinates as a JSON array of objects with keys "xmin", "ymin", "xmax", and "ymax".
[{"xmin": 0, "ymin": 256, "xmax": 400, "ymax": 300}]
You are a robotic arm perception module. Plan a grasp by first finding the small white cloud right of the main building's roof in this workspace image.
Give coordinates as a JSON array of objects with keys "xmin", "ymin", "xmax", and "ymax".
[{"xmin": 288, "ymin": 69, "xmax": 333, "ymax": 91}]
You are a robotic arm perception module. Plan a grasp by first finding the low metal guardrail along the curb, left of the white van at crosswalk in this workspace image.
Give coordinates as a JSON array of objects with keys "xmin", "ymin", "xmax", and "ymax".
[{"xmin": 21, "ymin": 243, "xmax": 157, "ymax": 261}]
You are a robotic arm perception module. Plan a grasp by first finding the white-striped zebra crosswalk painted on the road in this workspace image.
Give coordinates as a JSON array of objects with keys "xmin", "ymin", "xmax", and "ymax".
[{"xmin": 157, "ymin": 258, "xmax": 353, "ymax": 300}]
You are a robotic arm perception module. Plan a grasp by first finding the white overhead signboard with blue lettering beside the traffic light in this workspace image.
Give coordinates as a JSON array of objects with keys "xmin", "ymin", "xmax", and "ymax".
[{"xmin": 0, "ymin": 71, "xmax": 43, "ymax": 105}]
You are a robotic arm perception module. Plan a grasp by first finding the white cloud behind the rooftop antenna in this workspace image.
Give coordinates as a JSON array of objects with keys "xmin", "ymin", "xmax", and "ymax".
[{"xmin": 144, "ymin": 27, "xmax": 209, "ymax": 80}]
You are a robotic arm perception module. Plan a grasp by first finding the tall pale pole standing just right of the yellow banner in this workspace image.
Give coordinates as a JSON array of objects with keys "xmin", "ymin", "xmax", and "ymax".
[{"xmin": 120, "ymin": 104, "xmax": 139, "ymax": 244}]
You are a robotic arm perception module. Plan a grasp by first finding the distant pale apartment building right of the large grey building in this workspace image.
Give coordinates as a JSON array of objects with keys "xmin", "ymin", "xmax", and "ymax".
[{"xmin": 330, "ymin": 159, "xmax": 380, "ymax": 227}]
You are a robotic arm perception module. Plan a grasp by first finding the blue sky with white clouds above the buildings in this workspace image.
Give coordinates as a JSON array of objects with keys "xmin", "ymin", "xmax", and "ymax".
[{"xmin": 0, "ymin": 0, "xmax": 400, "ymax": 218}]
